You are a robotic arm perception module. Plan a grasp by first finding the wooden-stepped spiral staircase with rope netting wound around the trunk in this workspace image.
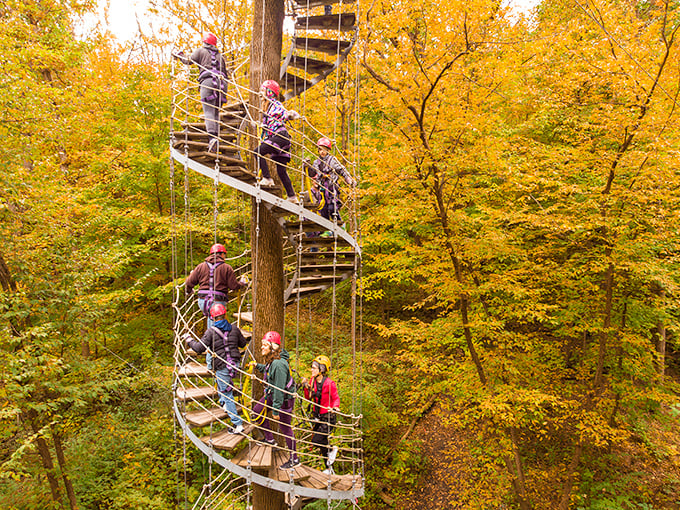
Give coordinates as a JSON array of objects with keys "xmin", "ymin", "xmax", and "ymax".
[{"xmin": 170, "ymin": 0, "xmax": 364, "ymax": 508}]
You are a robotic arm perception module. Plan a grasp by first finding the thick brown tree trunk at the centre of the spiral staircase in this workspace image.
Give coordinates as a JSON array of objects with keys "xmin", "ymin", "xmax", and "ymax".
[{"xmin": 250, "ymin": 0, "xmax": 286, "ymax": 510}]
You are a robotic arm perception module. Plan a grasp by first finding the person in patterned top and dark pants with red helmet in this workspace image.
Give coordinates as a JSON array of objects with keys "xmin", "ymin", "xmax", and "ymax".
[{"xmin": 257, "ymin": 80, "xmax": 300, "ymax": 204}]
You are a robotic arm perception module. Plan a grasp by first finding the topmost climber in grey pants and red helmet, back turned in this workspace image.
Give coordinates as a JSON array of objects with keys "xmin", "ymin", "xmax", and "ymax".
[{"xmin": 173, "ymin": 33, "xmax": 227, "ymax": 152}]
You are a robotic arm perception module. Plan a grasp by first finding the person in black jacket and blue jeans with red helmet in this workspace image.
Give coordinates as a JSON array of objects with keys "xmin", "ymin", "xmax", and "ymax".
[{"xmin": 186, "ymin": 303, "xmax": 248, "ymax": 434}]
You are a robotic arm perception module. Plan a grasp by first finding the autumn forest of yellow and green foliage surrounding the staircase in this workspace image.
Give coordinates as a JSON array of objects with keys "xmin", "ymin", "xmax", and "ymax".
[{"xmin": 0, "ymin": 0, "xmax": 680, "ymax": 509}]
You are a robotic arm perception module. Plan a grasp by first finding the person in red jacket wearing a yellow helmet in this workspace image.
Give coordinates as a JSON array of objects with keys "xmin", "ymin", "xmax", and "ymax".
[{"xmin": 302, "ymin": 355, "xmax": 340, "ymax": 474}]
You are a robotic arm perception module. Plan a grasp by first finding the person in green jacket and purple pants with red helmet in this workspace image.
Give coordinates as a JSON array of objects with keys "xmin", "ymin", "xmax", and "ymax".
[{"xmin": 251, "ymin": 331, "xmax": 300, "ymax": 469}]
